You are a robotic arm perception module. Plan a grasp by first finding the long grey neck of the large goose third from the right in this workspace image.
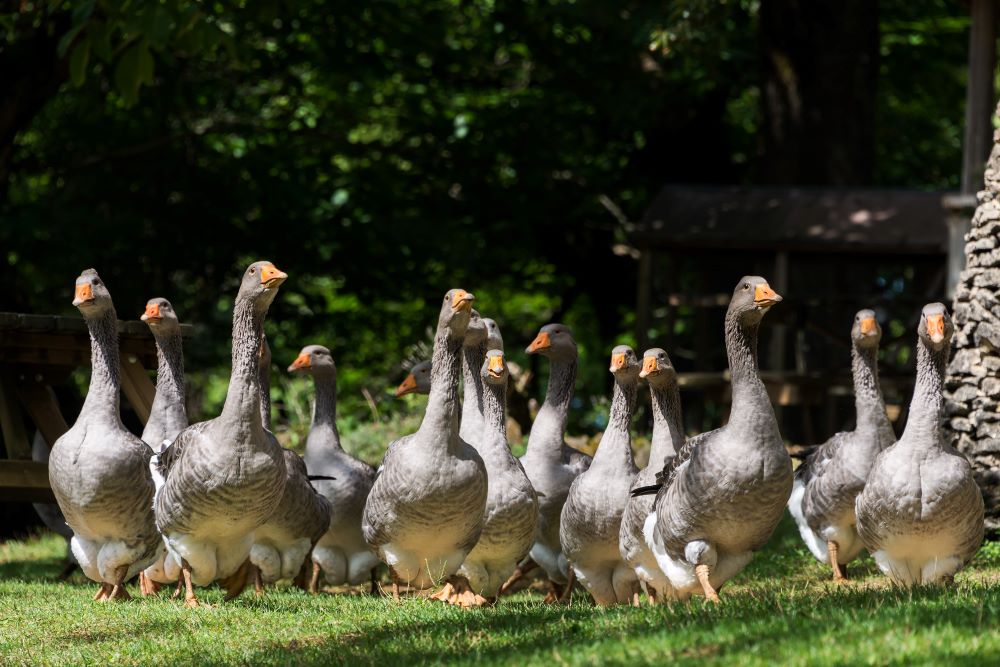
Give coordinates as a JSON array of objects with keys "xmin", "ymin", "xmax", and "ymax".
[{"xmin": 726, "ymin": 312, "xmax": 777, "ymax": 433}]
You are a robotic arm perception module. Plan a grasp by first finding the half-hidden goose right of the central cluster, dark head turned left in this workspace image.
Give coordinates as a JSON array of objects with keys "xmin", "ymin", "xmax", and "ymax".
[{"xmin": 504, "ymin": 323, "xmax": 591, "ymax": 602}]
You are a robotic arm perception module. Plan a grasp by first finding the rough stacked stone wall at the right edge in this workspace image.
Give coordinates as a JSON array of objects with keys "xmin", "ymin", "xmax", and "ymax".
[{"xmin": 945, "ymin": 102, "xmax": 1000, "ymax": 533}]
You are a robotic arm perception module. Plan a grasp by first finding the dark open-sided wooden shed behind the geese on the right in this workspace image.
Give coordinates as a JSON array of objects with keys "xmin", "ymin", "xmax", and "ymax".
[{"xmin": 630, "ymin": 186, "xmax": 961, "ymax": 443}]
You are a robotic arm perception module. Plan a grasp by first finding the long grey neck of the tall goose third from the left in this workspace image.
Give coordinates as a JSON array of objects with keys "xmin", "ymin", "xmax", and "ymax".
[{"xmin": 219, "ymin": 297, "xmax": 266, "ymax": 433}]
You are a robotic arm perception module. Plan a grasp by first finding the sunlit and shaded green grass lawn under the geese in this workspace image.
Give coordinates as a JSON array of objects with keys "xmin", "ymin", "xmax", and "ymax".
[{"xmin": 0, "ymin": 521, "xmax": 1000, "ymax": 665}]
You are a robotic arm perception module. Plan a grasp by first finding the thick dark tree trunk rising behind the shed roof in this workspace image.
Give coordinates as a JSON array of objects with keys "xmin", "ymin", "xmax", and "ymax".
[{"xmin": 760, "ymin": 0, "xmax": 879, "ymax": 186}]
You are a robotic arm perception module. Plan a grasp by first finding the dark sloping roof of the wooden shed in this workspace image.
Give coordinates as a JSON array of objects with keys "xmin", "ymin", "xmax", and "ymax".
[{"xmin": 631, "ymin": 185, "xmax": 949, "ymax": 255}]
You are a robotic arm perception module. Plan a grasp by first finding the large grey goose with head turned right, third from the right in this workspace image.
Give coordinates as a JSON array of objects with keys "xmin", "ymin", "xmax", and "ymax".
[{"xmin": 633, "ymin": 276, "xmax": 792, "ymax": 602}]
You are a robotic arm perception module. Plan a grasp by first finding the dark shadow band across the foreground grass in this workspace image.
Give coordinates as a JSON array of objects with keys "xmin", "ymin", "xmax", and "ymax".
[{"xmin": 229, "ymin": 585, "xmax": 1000, "ymax": 664}]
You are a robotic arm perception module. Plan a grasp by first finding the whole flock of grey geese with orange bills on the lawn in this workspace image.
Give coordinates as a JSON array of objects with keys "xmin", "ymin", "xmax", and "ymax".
[{"xmin": 49, "ymin": 261, "xmax": 984, "ymax": 607}]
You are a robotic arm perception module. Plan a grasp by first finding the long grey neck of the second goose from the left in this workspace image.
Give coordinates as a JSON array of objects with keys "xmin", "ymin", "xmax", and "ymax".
[{"xmin": 142, "ymin": 329, "xmax": 188, "ymax": 447}]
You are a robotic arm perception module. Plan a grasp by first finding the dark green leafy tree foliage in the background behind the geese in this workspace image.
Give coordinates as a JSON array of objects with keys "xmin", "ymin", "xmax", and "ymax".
[{"xmin": 0, "ymin": 0, "xmax": 968, "ymax": 442}]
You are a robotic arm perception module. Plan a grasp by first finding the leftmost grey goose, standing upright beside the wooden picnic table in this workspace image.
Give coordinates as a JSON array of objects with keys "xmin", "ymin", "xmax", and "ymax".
[{"xmin": 49, "ymin": 269, "xmax": 163, "ymax": 602}]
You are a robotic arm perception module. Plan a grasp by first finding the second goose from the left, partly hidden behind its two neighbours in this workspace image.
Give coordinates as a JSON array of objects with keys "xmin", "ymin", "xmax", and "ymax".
[{"xmin": 139, "ymin": 298, "xmax": 188, "ymax": 595}]
